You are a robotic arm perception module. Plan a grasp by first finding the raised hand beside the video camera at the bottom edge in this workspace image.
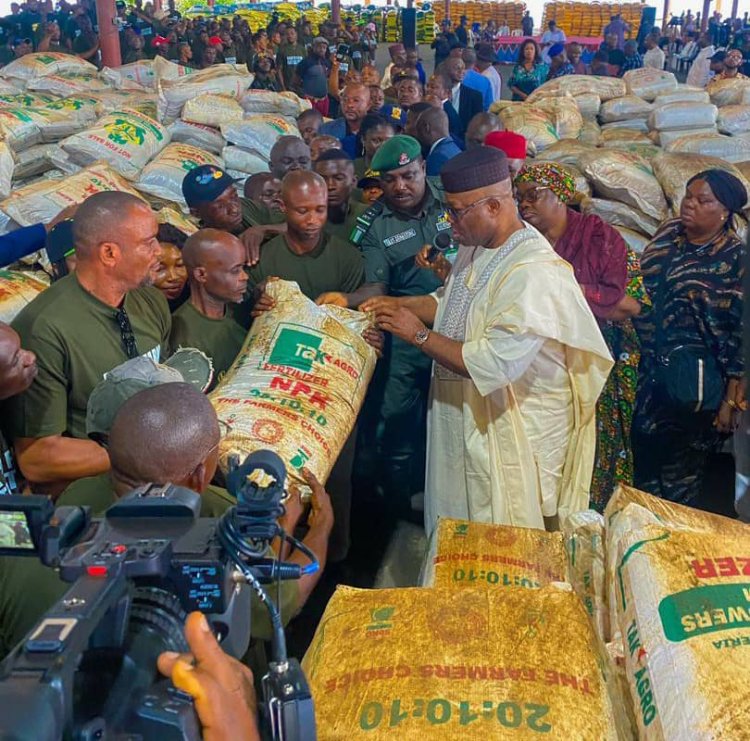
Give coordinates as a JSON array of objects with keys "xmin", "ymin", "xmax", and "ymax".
[{"xmin": 157, "ymin": 612, "xmax": 260, "ymax": 741}]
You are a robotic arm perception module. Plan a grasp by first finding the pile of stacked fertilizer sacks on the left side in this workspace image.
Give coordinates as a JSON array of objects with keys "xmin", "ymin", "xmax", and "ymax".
[{"xmin": 0, "ymin": 53, "xmax": 309, "ymax": 321}]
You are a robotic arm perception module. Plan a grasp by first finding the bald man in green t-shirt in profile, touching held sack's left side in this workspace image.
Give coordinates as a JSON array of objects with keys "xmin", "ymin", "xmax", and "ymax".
[{"xmin": 169, "ymin": 229, "xmax": 248, "ymax": 387}]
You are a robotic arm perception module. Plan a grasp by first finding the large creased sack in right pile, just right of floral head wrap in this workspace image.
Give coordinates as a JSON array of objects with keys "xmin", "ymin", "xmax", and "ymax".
[{"xmin": 579, "ymin": 149, "xmax": 667, "ymax": 221}]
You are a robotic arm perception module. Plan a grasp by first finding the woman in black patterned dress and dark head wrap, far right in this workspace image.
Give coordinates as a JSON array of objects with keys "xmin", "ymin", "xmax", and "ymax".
[{"xmin": 632, "ymin": 170, "xmax": 747, "ymax": 504}]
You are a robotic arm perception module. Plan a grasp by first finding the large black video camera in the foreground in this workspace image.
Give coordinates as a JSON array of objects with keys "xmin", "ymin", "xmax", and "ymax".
[{"xmin": 0, "ymin": 451, "xmax": 319, "ymax": 741}]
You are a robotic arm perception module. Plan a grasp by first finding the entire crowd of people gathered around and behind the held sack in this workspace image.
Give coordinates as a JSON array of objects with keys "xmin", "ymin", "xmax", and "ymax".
[{"xmin": 0, "ymin": 0, "xmax": 747, "ymax": 738}]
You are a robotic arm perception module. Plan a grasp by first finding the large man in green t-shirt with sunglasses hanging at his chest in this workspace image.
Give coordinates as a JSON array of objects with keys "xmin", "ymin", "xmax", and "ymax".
[{"xmin": 1, "ymin": 191, "xmax": 171, "ymax": 493}]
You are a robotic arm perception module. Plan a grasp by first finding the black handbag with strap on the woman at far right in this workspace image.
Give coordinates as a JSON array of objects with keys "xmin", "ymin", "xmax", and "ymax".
[{"xmin": 654, "ymin": 250, "xmax": 726, "ymax": 414}]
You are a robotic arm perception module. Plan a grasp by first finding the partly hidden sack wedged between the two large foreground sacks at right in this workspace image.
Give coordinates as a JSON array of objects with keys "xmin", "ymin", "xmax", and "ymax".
[{"xmin": 563, "ymin": 509, "xmax": 609, "ymax": 641}]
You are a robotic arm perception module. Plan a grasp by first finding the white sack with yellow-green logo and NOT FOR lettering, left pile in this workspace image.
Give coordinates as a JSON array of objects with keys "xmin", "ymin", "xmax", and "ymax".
[{"xmin": 60, "ymin": 108, "xmax": 169, "ymax": 180}]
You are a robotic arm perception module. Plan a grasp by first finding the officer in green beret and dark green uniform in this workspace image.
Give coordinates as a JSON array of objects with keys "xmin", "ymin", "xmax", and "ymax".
[{"xmin": 319, "ymin": 135, "xmax": 453, "ymax": 512}]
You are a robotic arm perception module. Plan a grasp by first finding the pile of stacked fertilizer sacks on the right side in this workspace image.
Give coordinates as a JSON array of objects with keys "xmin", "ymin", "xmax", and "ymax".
[{"xmin": 491, "ymin": 68, "xmax": 750, "ymax": 252}]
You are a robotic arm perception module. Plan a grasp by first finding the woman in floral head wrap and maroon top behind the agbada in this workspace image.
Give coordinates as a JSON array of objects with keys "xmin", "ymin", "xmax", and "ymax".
[{"xmin": 515, "ymin": 162, "xmax": 643, "ymax": 511}]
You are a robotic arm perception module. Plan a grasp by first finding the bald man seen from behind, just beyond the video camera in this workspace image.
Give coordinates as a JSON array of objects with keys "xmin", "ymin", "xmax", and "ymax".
[{"xmin": 0, "ymin": 383, "xmax": 333, "ymax": 660}]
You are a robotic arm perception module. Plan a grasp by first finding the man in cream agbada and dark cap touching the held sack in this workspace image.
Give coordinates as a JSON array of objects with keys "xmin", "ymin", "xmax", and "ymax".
[{"xmin": 362, "ymin": 147, "xmax": 612, "ymax": 535}]
